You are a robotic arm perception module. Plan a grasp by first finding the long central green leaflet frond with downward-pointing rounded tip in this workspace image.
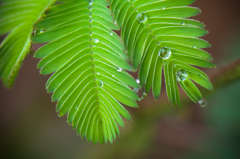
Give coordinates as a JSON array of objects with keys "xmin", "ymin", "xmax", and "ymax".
[{"xmin": 32, "ymin": 0, "xmax": 140, "ymax": 144}]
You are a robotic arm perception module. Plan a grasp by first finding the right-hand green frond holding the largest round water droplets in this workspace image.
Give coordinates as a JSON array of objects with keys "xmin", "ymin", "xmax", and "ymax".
[{"xmin": 109, "ymin": 0, "xmax": 215, "ymax": 106}]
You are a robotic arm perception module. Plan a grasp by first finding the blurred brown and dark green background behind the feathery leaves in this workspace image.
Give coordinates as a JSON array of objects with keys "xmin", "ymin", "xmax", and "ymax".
[{"xmin": 0, "ymin": 0, "xmax": 240, "ymax": 159}]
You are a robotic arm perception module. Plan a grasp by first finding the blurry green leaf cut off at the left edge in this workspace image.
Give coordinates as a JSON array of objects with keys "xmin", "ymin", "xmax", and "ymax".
[{"xmin": 0, "ymin": 0, "xmax": 52, "ymax": 88}]
